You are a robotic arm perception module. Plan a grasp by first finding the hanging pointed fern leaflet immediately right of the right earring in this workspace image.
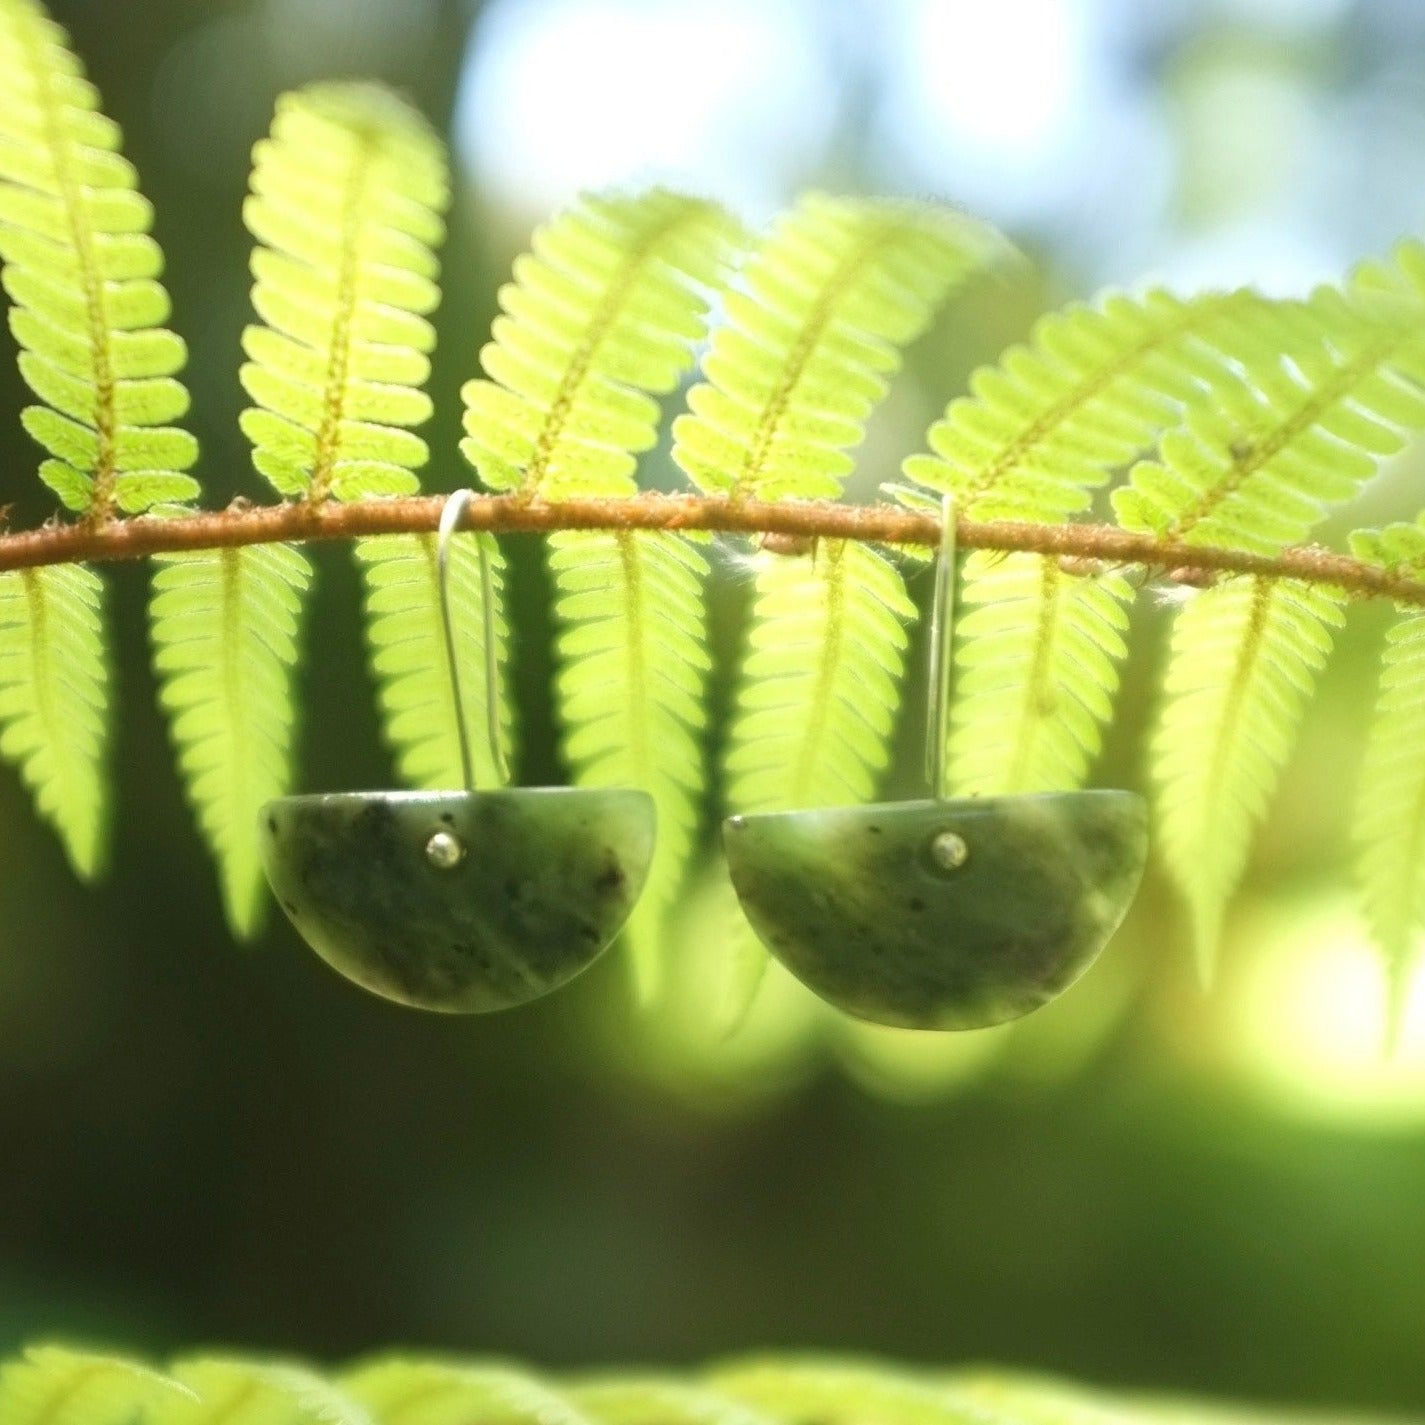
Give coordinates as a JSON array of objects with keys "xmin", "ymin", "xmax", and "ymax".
[{"xmin": 1153, "ymin": 579, "xmax": 1345, "ymax": 978}]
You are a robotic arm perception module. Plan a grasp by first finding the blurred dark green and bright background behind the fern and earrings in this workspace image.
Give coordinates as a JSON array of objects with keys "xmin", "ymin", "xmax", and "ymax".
[{"xmin": 0, "ymin": 0, "xmax": 1425, "ymax": 1409}]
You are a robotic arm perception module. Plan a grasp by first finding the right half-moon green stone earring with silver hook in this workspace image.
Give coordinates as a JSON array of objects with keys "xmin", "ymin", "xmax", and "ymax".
[{"xmin": 722, "ymin": 497, "xmax": 1147, "ymax": 1029}]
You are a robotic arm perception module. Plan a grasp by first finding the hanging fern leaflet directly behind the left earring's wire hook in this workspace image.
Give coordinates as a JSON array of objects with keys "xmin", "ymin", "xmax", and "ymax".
[{"xmin": 356, "ymin": 534, "xmax": 513, "ymax": 789}]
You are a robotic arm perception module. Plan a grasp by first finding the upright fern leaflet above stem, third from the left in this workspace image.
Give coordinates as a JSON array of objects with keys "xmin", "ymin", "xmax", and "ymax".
[{"xmin": 460, "ymin": 188, "xmax": 737, "ymax": 500}]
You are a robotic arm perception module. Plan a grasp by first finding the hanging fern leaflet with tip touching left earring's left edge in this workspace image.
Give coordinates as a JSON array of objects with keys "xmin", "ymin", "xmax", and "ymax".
[{"xmin": 150, "ymin": 544, "xmax": 311, "ymax": 939}]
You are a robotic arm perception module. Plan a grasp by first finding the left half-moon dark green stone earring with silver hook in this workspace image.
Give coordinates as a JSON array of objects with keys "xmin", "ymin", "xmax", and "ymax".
[{"xmin": 261, "ymin": 490, "xmax": 656, "ymax": 1013}]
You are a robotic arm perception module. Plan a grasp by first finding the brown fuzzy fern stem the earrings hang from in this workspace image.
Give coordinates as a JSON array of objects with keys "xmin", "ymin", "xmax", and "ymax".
[{"xmin": 0, "ymin": 494, "xmax": 1425, "ymax": 607}]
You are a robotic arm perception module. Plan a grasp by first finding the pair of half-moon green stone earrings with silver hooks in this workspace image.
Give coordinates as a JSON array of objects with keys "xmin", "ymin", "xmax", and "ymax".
[{"xmin": 262, "ymin": 490, "xmax": 1147, "ymax": 1029}]
